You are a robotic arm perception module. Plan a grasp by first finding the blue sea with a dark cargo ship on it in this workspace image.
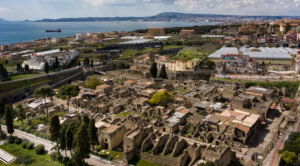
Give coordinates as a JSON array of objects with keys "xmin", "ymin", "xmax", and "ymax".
[{"xmin": 0, "ymin": 21, "xmax": 218, "ymax": 45}]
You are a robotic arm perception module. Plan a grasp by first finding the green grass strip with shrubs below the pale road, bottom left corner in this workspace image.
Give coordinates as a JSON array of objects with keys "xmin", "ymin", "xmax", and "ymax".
[{"xmin": 0, "ymin": 143, "xmax": 63, "ymax": 166}]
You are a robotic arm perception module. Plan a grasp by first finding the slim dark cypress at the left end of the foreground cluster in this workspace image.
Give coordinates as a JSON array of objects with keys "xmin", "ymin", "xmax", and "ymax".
[{"xmin": 49, "ymin": 115, "xmax": 60, "ymax": 153}]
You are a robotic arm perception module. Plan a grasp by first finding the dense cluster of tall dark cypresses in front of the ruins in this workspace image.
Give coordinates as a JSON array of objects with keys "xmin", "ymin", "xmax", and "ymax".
[{"xmin": 50, "ymin": 115, "xmax": 98, "ymax": 166}]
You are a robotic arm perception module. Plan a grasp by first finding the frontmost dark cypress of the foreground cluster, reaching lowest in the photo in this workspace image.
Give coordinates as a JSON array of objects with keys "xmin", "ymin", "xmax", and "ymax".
[{"xmin": 75, "ymin": 122, "xmax": 90, "ymax": 163}]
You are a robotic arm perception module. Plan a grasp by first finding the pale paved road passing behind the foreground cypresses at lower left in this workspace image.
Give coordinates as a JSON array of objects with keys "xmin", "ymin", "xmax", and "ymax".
[{"xmin": 2, "ymin": 125, "xmax": 117, "ymax": 166}]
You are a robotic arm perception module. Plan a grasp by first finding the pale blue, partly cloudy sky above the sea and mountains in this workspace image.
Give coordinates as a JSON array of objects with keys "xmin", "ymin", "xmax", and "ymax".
[{"xmin": 0, "ymin": 0, "xmax": 300, "ymax": 21}]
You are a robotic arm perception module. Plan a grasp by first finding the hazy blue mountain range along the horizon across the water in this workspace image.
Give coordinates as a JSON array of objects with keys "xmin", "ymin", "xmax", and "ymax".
[{"xmin": 36, "ymin": 12, "xmax": 300, "ymax": 22}]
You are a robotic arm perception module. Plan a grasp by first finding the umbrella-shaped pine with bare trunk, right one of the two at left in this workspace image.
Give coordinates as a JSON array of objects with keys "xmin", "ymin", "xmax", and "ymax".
[{"xmin": 58, "ymin": 84, "xmax": 79, "ymax": 111}]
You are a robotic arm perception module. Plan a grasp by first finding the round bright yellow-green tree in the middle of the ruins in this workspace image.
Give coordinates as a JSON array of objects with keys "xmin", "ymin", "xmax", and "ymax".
[{"xmin": 149, "ymin": 91, "xmax": 174, "ymax": 106}]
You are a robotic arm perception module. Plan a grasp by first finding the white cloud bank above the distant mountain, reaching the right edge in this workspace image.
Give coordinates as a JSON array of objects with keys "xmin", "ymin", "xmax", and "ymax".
[{"xmin": 83, "ymin": 0, "xmax": 300, "ymax": 15}]
